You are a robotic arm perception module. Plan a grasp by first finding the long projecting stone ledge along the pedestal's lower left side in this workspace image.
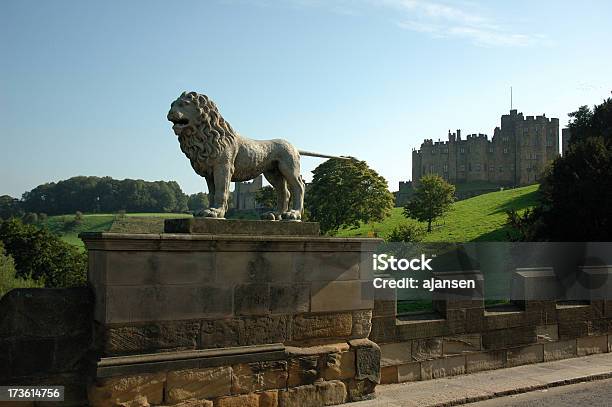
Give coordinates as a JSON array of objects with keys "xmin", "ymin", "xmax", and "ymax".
[{"xmin": 95, "ymin": 343, "xmax": 287, "ymax": 378}]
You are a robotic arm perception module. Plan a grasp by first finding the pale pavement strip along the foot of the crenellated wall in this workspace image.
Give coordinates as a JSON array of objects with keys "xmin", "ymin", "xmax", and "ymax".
[{"xmin": 350, "ymin": 353, "xmax": 612, "ymax": 407}]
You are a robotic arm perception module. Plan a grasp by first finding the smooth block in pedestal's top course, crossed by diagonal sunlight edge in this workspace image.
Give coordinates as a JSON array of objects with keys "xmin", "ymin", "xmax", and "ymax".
[{"xmin": 293, "ymin": 252, "xmax": 361, "ymax": 281}]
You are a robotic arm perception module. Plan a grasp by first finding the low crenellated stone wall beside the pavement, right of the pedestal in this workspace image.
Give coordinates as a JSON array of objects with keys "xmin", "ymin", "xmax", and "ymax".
[{"xmin": 370, "ymin": 266, "xmax": 612, "ymax": 383}]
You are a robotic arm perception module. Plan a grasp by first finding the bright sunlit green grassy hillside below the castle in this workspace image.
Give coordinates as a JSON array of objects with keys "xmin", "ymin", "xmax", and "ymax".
[{"xmin": 338, "ymin": 185, "xmax": 538, "ymax": 242}]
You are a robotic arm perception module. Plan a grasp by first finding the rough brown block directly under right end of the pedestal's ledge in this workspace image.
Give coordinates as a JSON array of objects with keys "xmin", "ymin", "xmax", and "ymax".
[{"xmin": 232, "ymin": 361, "xmax": 288, "ymax": 394}]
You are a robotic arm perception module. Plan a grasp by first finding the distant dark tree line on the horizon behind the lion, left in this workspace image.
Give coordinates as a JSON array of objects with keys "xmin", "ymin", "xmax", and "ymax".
[{"xmin": 0, "ymin": 177, "xmax": 215, "ymax": 219}]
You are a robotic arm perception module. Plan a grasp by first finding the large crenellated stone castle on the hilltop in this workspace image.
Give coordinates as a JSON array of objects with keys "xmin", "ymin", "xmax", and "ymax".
[{"xmin": 412, "ymin": 109, "xmax": 559, "ymax": 189}]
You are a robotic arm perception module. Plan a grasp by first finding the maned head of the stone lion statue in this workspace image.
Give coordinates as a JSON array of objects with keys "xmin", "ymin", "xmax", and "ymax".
[{"xmin": 168, "ymin": 92, "xmax": 236, "ymax": 168}]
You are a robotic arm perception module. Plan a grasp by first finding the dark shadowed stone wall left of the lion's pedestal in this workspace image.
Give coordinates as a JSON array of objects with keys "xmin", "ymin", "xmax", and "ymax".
[{"xmin": 0, "ymin": 288, "xmax": 93, "ymax": 406}]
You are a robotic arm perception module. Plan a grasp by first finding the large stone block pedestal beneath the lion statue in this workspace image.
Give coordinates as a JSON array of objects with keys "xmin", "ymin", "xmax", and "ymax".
[{"xmin": 82, "ymin": 220, "xmax": 380, "ymax": 406}]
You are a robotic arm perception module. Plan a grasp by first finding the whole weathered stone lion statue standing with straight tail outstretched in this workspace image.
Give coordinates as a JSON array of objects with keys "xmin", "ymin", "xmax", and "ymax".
[{"xmin": 168, "ymin": 92, "xmax": 344, "ymax": 221}]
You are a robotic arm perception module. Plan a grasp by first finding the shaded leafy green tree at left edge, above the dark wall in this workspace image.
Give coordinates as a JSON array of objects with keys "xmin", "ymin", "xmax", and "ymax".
[{"xmin": 0, "ymin": 218, "xmax": 87, "ymax": 287}]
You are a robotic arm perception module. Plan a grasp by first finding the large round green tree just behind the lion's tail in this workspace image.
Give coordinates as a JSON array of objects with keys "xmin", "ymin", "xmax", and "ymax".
[{"xmin": 305, "ymin": 158, "xmax": 394, "ymax": 234}]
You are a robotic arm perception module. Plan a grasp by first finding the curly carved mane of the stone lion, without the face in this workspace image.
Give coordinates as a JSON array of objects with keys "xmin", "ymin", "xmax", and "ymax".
[{"xmin": 179, "ymin": 92, "xmax": 236, "ymax": 167}]
